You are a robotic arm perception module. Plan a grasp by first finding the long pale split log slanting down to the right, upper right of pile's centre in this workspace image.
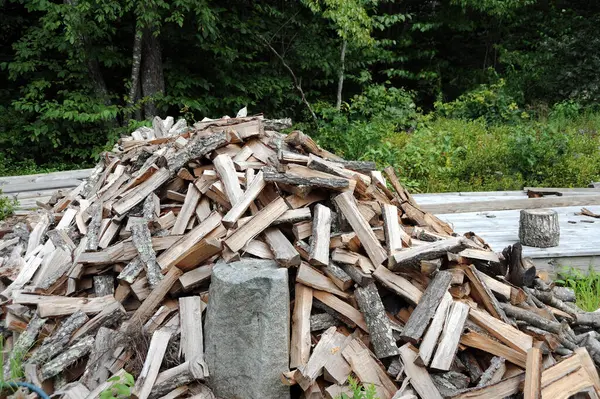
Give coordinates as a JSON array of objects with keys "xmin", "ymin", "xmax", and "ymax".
[{"xmin": 333, "ymin": 192, "xmax": 387, "ymax": 266}]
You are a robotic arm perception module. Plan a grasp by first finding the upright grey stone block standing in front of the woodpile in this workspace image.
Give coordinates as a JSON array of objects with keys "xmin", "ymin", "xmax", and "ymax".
[{"xmin": 204, "ymin": 259, "xmax": 290, "ymax": 399}]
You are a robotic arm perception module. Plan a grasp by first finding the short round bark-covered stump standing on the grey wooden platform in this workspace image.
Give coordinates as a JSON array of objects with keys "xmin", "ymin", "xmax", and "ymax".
[{"xmin": 519, "ymin": 209, "xmax": 560, "ymax": 248}]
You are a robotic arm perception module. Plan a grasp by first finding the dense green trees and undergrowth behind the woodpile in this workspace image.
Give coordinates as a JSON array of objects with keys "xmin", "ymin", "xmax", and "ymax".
[{"xmin": 0, "ymin": 0, "xmax": 600, "ymax": 190}]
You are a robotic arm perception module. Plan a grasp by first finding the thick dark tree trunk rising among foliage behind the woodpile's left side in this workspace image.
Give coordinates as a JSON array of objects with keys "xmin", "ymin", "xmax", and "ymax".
[{"xmin": 142, "ymin": 29, "xmax": 165, "ymax": 119}]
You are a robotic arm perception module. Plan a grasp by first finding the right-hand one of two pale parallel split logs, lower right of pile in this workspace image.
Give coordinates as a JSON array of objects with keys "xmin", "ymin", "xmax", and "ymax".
[{"xmin": 428, "ymin": 304, "xmax": 469, "ymax": 371}]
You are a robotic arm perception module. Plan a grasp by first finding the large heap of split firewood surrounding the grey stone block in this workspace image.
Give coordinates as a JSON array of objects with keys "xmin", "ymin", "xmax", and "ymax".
[{"xmin": 0, "ymin": 116, "xmax": 600, "ymax": 399}]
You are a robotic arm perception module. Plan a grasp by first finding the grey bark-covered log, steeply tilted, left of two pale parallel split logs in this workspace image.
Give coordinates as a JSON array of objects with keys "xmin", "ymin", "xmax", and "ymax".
[{"xmin": 354, "ymin": 283, "xmax": 400, "ymax": 359}]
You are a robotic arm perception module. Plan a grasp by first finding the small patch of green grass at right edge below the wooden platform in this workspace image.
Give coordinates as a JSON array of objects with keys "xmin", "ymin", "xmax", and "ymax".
[{"xmin": 556, "ymin": 266, "xmax": 600, "ymax": 312}]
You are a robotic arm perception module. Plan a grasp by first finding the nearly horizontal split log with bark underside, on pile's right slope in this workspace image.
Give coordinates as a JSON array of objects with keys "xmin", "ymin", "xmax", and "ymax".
[{"xmin": 390, "ymin": 237, "xmax": 470, "ymax": 271}]
